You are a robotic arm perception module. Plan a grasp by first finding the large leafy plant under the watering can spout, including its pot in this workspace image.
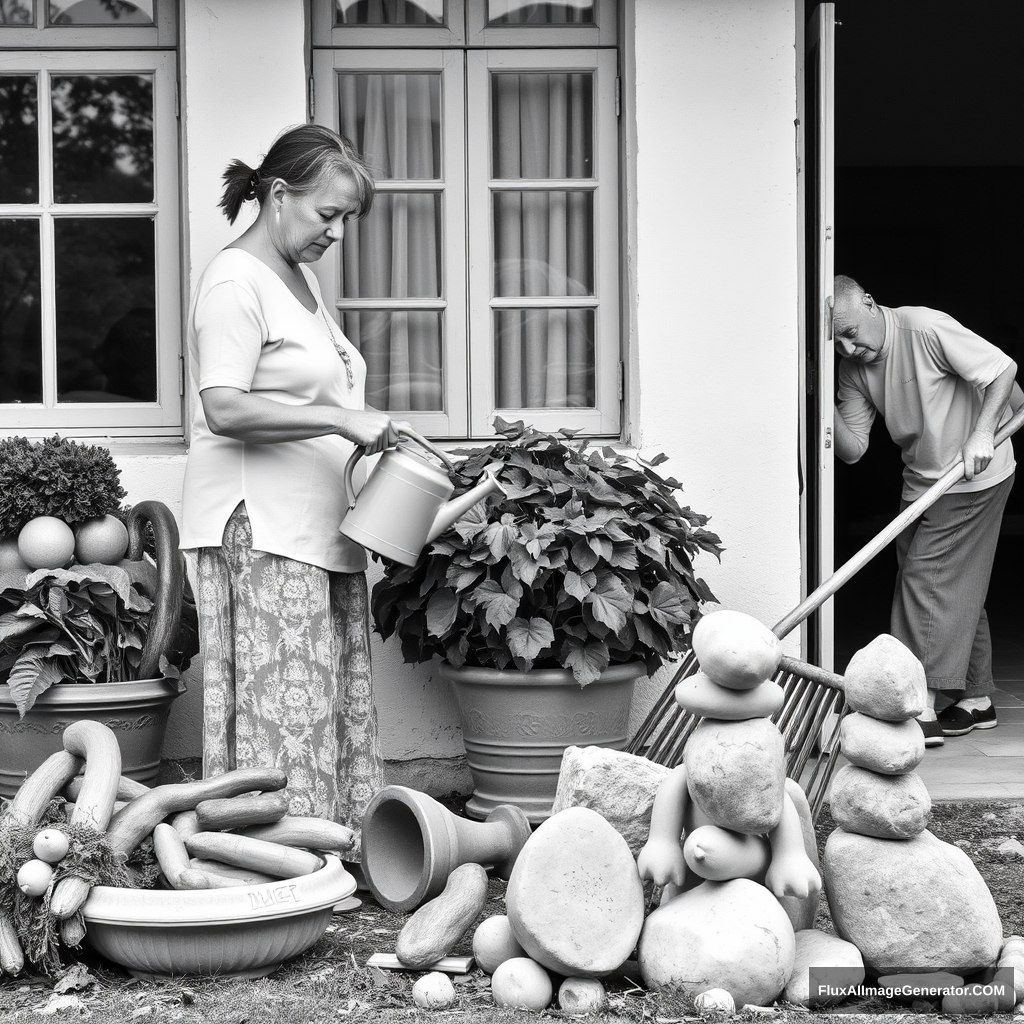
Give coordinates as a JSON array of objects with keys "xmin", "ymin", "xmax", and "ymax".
[{"xmin": 371, "ymin": 417, "xmax": 722, "ymax": 821}]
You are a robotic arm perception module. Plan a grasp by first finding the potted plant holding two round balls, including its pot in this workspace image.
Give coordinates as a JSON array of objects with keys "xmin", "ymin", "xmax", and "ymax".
[{"xmin": 0, "ymin": 436, "xmax": 198, "ymax": 797}]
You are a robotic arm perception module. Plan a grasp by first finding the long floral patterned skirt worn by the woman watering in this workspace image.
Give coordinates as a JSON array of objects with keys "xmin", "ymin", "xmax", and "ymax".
[{"xmin": 195, "ymin": 503, "xmax": 384, "ymax": 861}]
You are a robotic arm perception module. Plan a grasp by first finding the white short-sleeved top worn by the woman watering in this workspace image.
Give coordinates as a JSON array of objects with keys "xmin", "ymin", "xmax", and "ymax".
[{"xmin": 181, "ymin": 249, "xmax": 367, "ymax": 572}]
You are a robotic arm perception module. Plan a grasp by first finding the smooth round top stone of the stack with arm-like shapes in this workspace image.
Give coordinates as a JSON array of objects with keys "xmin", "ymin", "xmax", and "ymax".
[{"xmin": 692, "ymin": 608, "xmax": 782, "ymax": 690}]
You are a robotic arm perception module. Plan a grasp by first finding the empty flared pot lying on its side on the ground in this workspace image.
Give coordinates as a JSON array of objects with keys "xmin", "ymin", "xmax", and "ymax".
[{"xmin": 362, "ymin": 785, "xmax": 530, "ymax": 913}]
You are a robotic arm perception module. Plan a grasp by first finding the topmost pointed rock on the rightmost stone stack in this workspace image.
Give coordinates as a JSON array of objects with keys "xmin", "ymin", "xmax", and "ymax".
[{"xmin": 843, "ymin": 633, "xmax": 928, "ymax": 722}]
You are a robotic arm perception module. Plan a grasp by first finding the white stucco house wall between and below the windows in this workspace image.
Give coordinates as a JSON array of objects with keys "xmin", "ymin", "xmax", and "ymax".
[{"xmin": 113, "ymin": 0, "xmax": 800, "ymax": 760}]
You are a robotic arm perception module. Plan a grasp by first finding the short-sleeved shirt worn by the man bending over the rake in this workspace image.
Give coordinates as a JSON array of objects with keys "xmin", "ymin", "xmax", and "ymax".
[{"xmin": 838, "ymin": 306, "xmax": 1015, "ymax": 501}]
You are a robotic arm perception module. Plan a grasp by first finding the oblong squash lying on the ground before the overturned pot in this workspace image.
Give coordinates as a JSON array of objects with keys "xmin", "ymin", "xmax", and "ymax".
[{"xmin": 394, "ymin": 863, "xmax": 489, "ymax": 966}]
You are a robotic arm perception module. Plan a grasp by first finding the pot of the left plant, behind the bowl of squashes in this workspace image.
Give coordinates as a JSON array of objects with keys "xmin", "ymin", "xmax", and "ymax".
[{"xmin": 0, "ymin": 679, "xmax": 184, "ymax": 798}]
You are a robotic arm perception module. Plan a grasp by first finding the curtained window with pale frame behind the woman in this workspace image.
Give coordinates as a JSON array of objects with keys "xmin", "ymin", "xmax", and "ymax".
[{"xmin": 313, "ymin": 0, "xmax": 621, "ymax": 437}]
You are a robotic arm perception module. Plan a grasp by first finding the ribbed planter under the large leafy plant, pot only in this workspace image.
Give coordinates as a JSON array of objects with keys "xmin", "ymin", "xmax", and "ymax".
[{"xmin": 440, "ymin": 662, "xmax": 647, "ymax": 824}]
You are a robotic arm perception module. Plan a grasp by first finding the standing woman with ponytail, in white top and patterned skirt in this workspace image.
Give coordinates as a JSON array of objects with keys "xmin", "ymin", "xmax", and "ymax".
[{"xmin": 181, "ymin": 125, "xmax": 397, "ymax": 861}]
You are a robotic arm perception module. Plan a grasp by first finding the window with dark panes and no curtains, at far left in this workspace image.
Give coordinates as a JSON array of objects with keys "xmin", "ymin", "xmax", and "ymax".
[{"xmin": 0, "ymin": 0, "xmax": 181, "ymax": 434}]
